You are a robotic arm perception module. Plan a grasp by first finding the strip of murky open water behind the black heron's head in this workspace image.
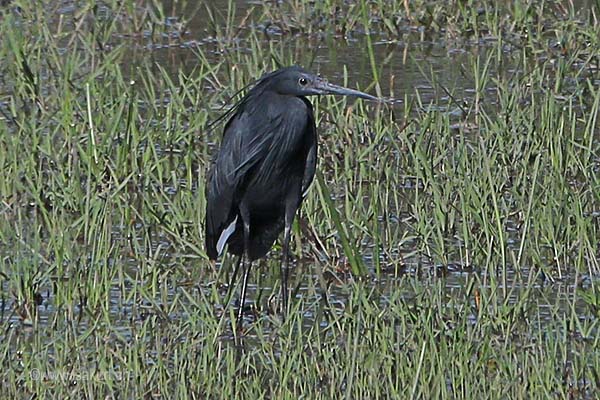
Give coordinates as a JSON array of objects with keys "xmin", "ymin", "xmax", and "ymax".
[{"xmin": 125, "ymin": 0, "xmax": 491, "ymax": 104}]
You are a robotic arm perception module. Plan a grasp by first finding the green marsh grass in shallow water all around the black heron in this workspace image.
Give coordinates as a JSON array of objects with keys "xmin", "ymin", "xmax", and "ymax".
[{"xmin": 0, "ymin": 0, "xmax": 600, "ymax": 399}]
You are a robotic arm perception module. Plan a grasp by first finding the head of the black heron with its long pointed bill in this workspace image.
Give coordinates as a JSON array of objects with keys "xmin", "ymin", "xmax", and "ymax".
[{"xmin": 260, "ymin": 66, "xmax": 379, "ymax": 101}]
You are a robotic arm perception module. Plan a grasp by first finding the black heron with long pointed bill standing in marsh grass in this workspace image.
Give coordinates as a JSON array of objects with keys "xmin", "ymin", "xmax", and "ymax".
[{"xmin": 205, "ymin": 66, "xmax": 379, "ymax": 323}]
